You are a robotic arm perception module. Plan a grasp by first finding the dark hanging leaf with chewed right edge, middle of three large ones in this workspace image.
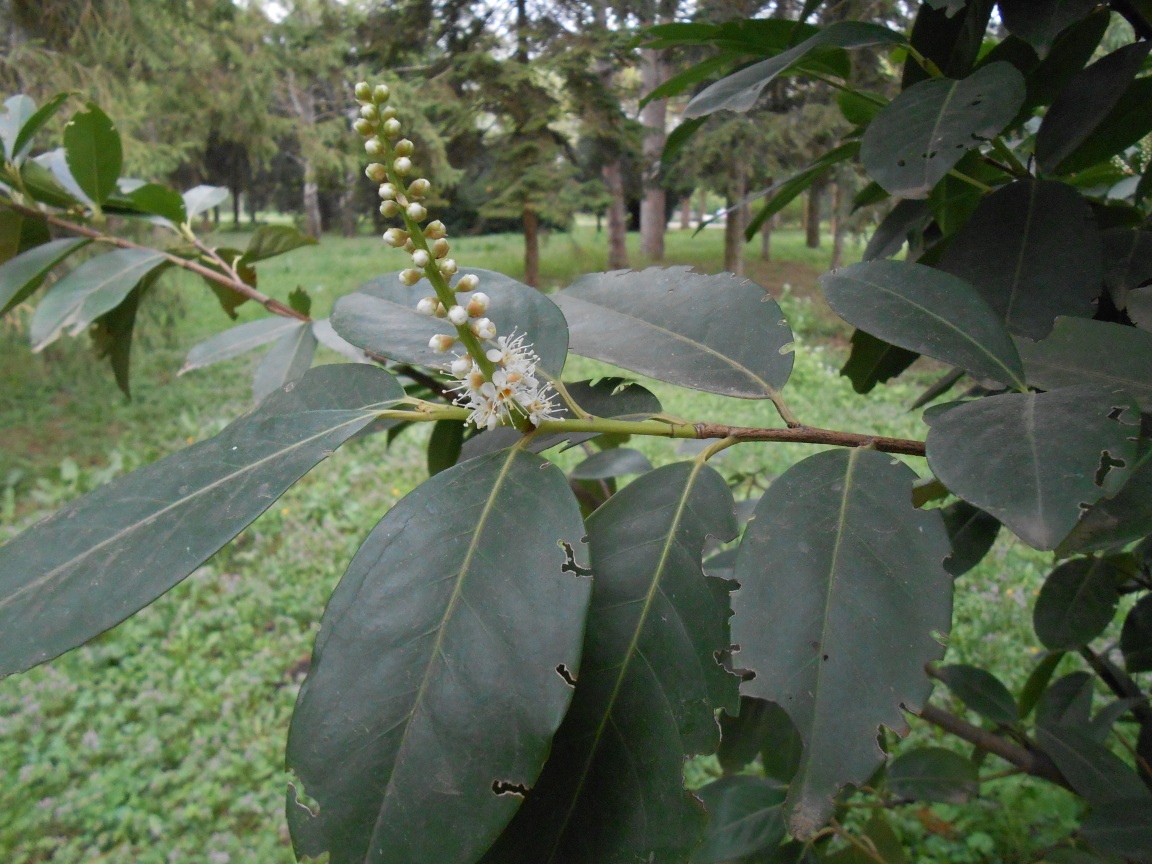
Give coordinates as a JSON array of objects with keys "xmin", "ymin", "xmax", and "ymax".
[{"xmin": 483, "ymin": 462, "xmax": 737, "ymax": 864}]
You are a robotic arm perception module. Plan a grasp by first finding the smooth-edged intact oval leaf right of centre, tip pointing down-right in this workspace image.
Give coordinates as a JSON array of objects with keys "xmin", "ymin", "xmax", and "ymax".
[{"xmin": 820, "ymin": 260, "xmax": 1024, "ymax": 388}]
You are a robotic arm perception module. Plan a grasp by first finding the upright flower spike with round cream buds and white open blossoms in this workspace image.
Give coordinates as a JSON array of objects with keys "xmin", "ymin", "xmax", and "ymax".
[{"xmin": 354, "ymin": 82, "xmax": 558, "ymax": 430}]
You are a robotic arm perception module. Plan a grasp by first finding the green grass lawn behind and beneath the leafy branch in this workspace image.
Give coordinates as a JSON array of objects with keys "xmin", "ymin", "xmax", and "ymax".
[{"xmin": 0, "ymin": 228, "xmax": 1076, "ymax": 864}]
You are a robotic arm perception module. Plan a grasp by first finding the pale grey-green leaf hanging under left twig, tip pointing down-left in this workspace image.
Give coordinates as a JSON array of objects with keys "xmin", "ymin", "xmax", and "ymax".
[{"xmin": 30, "ymin": 249, "xmax": 167, "ymax": 351}]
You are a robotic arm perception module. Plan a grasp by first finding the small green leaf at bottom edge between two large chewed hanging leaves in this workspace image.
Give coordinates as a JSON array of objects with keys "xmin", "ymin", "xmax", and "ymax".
[{"xmin": 691, "ymin": 775, "xmax": 788, "ymax": 864}]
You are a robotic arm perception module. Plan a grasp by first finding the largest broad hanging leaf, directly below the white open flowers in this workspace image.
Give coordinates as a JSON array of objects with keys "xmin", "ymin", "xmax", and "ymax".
[{"xmin": 288, "ymin": 449, "xmax": 594, "ymax": 864}]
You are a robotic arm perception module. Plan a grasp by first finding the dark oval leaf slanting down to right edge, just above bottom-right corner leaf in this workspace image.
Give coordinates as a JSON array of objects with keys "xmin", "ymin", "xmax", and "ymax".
[{"xmin": 1036, "ymin": 723, "xmax": 1152, "ymax": 811}]
